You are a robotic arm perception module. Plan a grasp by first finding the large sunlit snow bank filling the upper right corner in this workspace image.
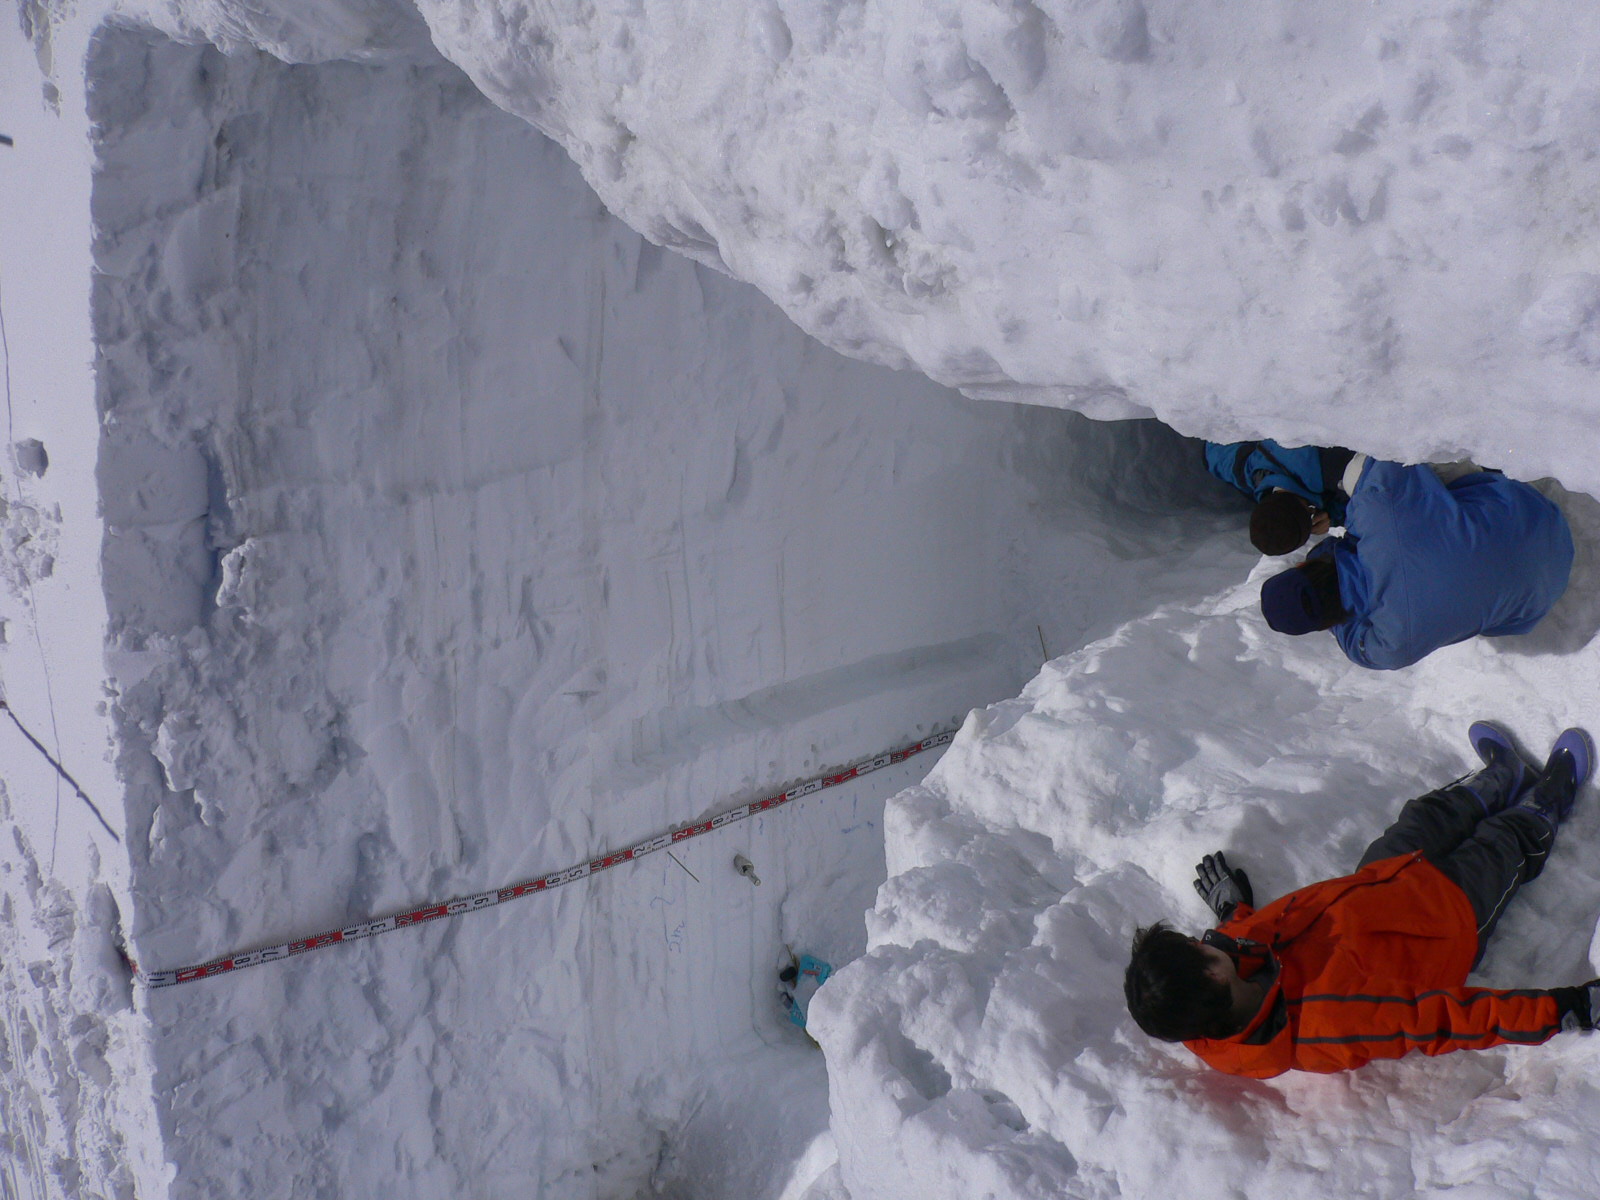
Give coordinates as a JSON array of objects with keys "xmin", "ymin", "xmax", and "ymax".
[{"xmin": 419, "ymin": 0, "xmax": 1600, "ymax": 490}]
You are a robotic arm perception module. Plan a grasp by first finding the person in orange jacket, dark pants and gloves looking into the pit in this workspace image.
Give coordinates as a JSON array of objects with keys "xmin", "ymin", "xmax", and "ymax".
[{"xmin": 1123, "ymin": 722, "xmax": 1600, "ymax": 1078}]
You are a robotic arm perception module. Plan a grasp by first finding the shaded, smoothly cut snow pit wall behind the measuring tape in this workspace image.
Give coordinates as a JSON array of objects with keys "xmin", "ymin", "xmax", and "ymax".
[{"xmin": 75, "ymin": 29, "xmax": 1254, "ymax": 1200}]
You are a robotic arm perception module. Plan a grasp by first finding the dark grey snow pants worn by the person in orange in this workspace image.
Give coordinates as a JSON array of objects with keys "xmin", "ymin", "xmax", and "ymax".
[{"xmin": 1360, "ymin": 765, "xmax": 1555, "ymax": 966}]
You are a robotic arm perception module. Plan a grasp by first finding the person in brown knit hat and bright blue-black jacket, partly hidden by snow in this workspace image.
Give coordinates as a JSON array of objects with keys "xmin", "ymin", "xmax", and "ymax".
[{"xmin": 1205, "ymin": 438, "xmax": 1352, "ymax": 555}]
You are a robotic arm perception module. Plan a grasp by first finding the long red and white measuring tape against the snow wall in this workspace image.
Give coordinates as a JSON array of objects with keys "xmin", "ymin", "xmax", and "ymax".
[{"xmin": 139, "ymin": 730, "xmax": 955, "ymax": 987}]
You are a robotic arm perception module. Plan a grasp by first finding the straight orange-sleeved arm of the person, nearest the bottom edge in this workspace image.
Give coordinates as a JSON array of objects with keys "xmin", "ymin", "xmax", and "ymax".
[{"xmin": 1288, "ymin": 979, "xmax": 1592, "ymax": 1072}]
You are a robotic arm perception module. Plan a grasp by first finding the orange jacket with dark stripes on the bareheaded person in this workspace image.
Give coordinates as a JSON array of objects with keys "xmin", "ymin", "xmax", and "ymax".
[{"xmin": 1184, "ymin": 851, "xmax": 1562, "ymax": 1078}]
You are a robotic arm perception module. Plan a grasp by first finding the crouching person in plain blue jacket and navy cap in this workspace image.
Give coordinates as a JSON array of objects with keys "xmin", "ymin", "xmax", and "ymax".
[{"xmin": 1261, "ymin": 459, "xmax": 1573, "ymax": 670}]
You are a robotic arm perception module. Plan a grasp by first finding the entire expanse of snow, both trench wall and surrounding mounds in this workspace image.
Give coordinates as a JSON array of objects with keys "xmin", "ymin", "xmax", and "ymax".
[{"xmin": 9, "ymin": 0, "xmax": 1600, "ymax": 1200}]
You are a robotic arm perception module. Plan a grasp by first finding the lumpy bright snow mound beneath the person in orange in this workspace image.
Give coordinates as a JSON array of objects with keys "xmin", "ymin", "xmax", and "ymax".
[{"xmin": 811, "ymin": 563, "xmax": 1600, "ymax": 1200}]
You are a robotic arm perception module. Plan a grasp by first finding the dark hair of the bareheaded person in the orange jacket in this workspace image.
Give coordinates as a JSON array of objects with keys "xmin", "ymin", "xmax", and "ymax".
[{"xmin": 1122, "ymin": 922, "xmax": 1240, "ymax": 1042}]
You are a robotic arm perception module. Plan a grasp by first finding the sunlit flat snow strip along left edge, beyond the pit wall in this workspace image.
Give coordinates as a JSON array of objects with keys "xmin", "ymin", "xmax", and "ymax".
[{"xmin": 0, "ymin": 22, "xmax": 166, "ymax": 1200}]
